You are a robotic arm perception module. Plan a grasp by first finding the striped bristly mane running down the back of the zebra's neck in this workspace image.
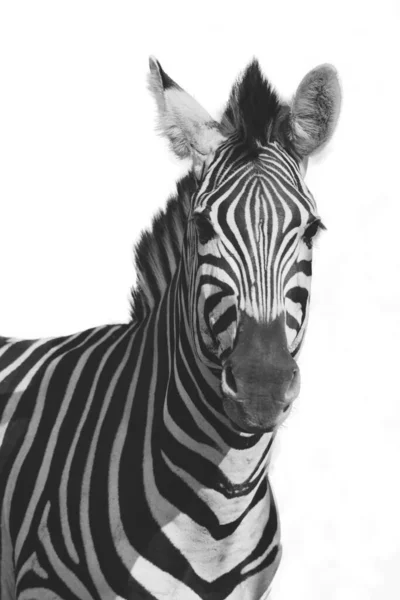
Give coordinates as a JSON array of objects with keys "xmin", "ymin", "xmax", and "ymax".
[{"xmin": 131, "ymin": 172, "xmax": 198, "ymax": 320}]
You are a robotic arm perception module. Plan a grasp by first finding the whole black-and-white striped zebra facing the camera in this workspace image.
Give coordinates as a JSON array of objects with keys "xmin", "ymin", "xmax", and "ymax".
[{"xmin": 0, "ymin": 57, "xmax": 341, "ymax": 600}]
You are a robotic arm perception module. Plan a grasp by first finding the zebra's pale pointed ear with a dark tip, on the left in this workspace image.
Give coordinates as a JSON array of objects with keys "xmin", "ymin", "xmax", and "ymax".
[{"xmin": 148, "ymin": 57, "xmax": 225, "ymax": 175}]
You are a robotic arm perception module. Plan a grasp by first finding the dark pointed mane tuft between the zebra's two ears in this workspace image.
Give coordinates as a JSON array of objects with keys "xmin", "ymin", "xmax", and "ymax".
[{"xmin": 221, "ymin": 59, "xmax": 287, "ymax": 156}]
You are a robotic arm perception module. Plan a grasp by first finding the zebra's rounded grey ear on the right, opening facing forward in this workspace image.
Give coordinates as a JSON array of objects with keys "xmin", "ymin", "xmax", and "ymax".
[{"xmin": 289, "ymin": 65, "xmax": 341, "ymax": 158}]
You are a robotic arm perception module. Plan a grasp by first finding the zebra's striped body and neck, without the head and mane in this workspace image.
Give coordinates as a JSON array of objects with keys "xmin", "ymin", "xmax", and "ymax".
[{"xmin": 0, "ymin": 299, "xmax": 280, "ymax": 599}]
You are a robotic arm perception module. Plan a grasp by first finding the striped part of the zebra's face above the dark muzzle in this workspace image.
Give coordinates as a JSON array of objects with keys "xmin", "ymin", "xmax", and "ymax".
[{"xmin": 189, "ymin": 140, "xmax": 322, "ymax": 360}]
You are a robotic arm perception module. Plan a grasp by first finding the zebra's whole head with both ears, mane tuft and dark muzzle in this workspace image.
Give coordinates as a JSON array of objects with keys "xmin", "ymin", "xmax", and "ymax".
[{"xmin": 149, "ymin": 59, "xmax": 340, "ymax": 432}]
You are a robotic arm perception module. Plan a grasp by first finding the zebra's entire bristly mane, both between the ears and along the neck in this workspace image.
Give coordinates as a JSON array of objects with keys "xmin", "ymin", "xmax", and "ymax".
[{"xmin": 131, "ymin": 60, "xmax": 287, "ymax": 320}]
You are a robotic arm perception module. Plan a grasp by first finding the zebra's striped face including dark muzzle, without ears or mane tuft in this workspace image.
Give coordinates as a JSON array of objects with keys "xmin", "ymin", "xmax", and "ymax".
[{"xmin": 189, "ymin": 142, "xmax": 323, "ymax": 430}]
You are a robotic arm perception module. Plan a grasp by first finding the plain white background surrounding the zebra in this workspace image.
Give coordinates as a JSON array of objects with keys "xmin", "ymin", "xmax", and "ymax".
[{"xmin": 0, "ymin": 0, "xmax": 400, "ymax": 600}]
